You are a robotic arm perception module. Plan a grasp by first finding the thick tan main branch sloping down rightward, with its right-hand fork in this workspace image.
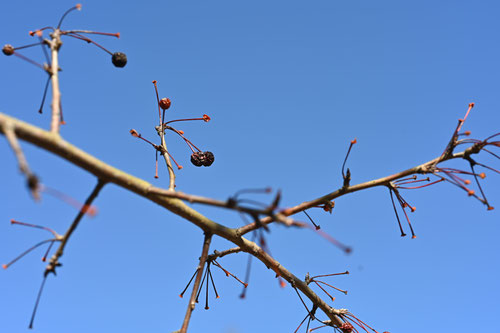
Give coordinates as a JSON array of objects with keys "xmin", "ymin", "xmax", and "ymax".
[{"xmin": 4, "ymin": 113, "xmax": 468, "ymax": 326}]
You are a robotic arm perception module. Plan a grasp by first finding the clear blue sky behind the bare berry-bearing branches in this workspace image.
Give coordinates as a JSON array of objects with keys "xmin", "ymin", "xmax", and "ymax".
[{"xmin": 0, "ymin": 0, "xmax": 500, "ymax": 333}]
